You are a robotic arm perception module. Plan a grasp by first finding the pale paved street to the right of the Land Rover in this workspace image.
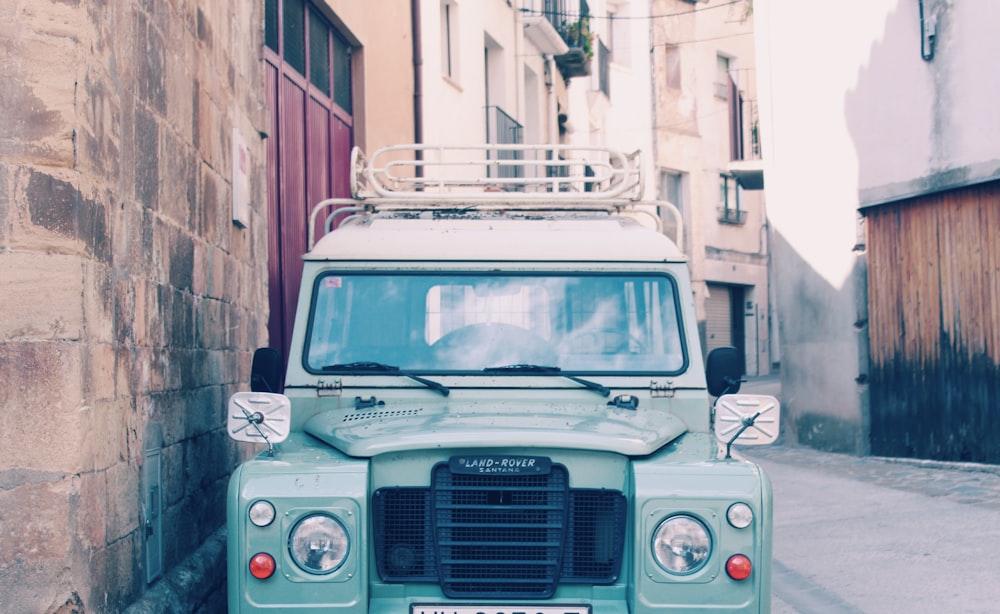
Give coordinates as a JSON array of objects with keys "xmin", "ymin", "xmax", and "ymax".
[{"xmin": 743, "ymin": 382, "xmax": 1000, "ymax": 614}]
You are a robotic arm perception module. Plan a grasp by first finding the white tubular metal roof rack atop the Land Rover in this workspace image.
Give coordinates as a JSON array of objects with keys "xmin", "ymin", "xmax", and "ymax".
[{"xmin": 309, "ymin": 144, "xmax": 672, "ymax": 249}]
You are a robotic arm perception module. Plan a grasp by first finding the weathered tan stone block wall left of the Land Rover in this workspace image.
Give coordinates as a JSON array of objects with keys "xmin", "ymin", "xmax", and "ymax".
[{"xmin": 0, "ymin": 0, "xmax": 267, "ymax": 612}]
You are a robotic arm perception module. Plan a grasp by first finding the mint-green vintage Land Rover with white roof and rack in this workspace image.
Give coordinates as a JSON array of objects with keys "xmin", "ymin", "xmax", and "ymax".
[{"xmin": 227, "ymin": 146, "xmax": 779, "ymax": 614}]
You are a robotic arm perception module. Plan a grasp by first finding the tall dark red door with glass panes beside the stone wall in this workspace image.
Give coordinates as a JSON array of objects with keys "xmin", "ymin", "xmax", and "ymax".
[{"xmin": 265, "ymin": 0, "xmax": 354, "ymax": 376}]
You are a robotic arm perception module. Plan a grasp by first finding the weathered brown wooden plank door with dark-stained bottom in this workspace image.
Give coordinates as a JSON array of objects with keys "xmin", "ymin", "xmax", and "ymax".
[{"xmin": 864, "ymin": 182, "xmax": 1000, "ymax": 463}]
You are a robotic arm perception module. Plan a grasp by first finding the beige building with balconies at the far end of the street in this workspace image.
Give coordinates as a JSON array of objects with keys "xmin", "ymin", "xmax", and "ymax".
[{"xmin": 649, "ymin": 0, "xmax": 781, "ymax": 375}]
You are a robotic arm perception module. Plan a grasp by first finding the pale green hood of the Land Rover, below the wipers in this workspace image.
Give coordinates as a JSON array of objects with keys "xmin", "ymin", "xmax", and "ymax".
[{"xmin": 304, "ymin": 401, "xmax": 687, "ymax": 457}]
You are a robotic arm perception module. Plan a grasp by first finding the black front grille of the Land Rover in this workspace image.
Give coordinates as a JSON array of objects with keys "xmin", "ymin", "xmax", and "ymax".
[{"xmin": 372, "ymin": 463, "xmax": 626, "ymax": 599}]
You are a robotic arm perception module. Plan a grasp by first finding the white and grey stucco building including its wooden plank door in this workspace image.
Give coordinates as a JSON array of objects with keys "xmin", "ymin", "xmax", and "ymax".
[{"xmin": 754, "ymin": 0, "xmax": 1000, "ymax": 463}]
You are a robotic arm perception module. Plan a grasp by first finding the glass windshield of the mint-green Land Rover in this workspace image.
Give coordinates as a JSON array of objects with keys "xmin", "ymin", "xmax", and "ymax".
[{"xmin": 305, "ymin": 271, "xmax": 686, "ymax": 373}]
